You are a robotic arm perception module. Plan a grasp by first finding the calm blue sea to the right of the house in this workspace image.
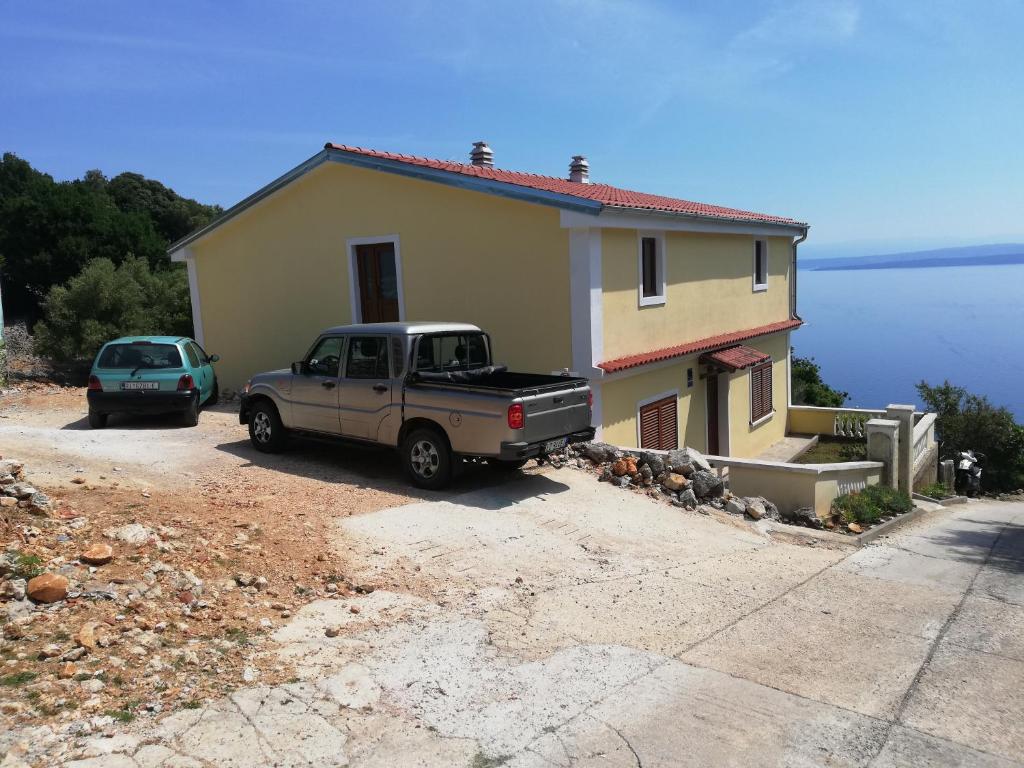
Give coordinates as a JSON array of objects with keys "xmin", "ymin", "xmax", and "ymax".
[{"xmin": 792, "ymin": 264, "xmax": 1024, "ymax": 423}]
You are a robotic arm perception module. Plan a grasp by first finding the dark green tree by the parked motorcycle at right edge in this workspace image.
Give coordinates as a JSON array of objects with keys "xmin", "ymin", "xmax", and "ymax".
[{"xmin": 918, "ymin": 381, "xmax": 1024, "ymax": 490}]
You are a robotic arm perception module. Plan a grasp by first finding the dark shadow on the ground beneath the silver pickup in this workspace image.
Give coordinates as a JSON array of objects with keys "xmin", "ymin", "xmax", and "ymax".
[{"xmin": 216, "ymin": 437, "xmax": 568, "ymax": 510}]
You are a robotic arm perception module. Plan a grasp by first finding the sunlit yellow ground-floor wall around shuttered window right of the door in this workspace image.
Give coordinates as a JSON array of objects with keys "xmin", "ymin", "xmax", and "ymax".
[{"xmin": 729, "ymin": 333, "xmax": 790, "ymax": 457}]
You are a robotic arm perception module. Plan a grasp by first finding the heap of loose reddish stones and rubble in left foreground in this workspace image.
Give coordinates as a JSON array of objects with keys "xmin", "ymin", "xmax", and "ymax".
[{"xmin": 0, "ymin": 459, "xmax": 360, "ymax": 730}]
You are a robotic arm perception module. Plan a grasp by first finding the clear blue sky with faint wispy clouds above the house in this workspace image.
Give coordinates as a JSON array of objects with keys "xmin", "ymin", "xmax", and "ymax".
[{"xmin": 0, "ymin": 0, "xmax": 1024, "ymax": 255}]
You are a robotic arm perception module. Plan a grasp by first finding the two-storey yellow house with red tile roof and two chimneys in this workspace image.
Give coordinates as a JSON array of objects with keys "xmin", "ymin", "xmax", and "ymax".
[{"xmin": 170, "ymin": 142, "xmax": 808, "ymax": 457}]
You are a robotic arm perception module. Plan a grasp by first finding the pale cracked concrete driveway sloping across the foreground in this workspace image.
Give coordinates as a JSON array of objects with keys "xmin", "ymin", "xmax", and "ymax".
[{"xmin": 17, "ymin": 470, "xmax": 1024, "ymax": 768}]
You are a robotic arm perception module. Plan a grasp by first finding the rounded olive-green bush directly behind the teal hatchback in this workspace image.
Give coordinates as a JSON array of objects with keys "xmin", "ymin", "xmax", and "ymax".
[{"xmin": 36, "ymin": 257, "xmax": 193, "ymax": 362}]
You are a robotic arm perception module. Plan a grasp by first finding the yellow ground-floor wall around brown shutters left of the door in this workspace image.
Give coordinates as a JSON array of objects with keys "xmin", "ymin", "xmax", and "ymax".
[{"xmin": 598, "ymin": 356, "xmax": 708, "ymax": 451}]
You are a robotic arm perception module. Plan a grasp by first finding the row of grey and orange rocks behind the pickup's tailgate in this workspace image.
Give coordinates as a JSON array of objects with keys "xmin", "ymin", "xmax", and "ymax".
[{"xmin": 553, "ymin": 442, "xmax": 822, "ymax": 527}]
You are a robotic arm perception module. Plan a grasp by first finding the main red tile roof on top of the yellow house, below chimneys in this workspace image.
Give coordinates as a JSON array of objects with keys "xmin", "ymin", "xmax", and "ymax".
[{"xmin": 325, "ymin": 143, "xmax": 803, "ymax": 226}]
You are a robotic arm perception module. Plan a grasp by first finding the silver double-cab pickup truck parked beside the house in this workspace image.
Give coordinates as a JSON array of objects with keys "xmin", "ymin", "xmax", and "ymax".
[{"xmin": 239, "ymin": 323, "xmax": 594, "ymax": 488}]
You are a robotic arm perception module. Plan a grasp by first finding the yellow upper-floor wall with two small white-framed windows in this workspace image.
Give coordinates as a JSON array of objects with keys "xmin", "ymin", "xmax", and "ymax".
[{"xmin": 601, "ymin": 229, "xmax": 793, "ymax": 360}]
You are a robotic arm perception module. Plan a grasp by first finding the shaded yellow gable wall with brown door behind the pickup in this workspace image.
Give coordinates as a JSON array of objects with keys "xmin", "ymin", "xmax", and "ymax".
[{"xmin": 190, "ymin": 163, "xmax": 571, "ymax": 389}]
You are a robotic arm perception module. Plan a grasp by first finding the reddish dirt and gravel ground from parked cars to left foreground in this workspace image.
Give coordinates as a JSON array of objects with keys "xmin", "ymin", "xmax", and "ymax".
[{"xmin": 0, "ymin": 384, "xmax": 520, "ymax": 723}]
